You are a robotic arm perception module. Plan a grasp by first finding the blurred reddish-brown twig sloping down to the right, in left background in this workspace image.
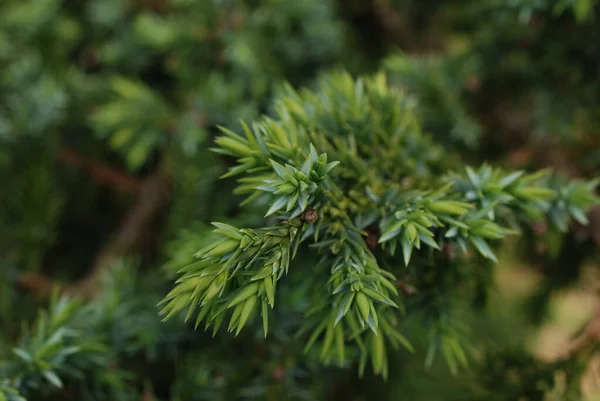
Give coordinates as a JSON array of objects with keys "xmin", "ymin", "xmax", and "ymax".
[{"xmin": 58, "ymin": 148, "xmax": 142, "ymax": 194}]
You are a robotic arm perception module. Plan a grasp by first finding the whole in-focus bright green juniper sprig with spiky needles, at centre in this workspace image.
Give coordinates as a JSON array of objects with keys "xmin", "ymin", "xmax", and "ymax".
[{"xmin": 162, "ymin": 73, "xmax": 597, "ymax": 376}]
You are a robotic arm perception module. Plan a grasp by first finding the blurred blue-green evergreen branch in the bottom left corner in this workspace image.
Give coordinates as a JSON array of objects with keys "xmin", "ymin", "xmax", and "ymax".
[{"xmin": 0, "ymin": 263, "xmax": 177, "ymax": 401}]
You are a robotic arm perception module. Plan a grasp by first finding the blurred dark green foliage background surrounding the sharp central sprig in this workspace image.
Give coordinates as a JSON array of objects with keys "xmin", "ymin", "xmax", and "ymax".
[{"xmin": 0, "ymin": 0, "xmax": 600, "ymax": 401}]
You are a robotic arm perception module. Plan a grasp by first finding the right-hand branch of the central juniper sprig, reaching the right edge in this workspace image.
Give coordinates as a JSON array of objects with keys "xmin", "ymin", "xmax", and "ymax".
[{"xmin": 370, "ymin": 165, "xmax": 599, "ymax": 265}]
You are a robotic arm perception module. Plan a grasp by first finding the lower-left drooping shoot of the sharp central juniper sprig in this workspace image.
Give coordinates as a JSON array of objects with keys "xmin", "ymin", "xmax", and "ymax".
[{"xmin": 160, "ymin": 219, "xmax": 304, "ymax": 336}]
